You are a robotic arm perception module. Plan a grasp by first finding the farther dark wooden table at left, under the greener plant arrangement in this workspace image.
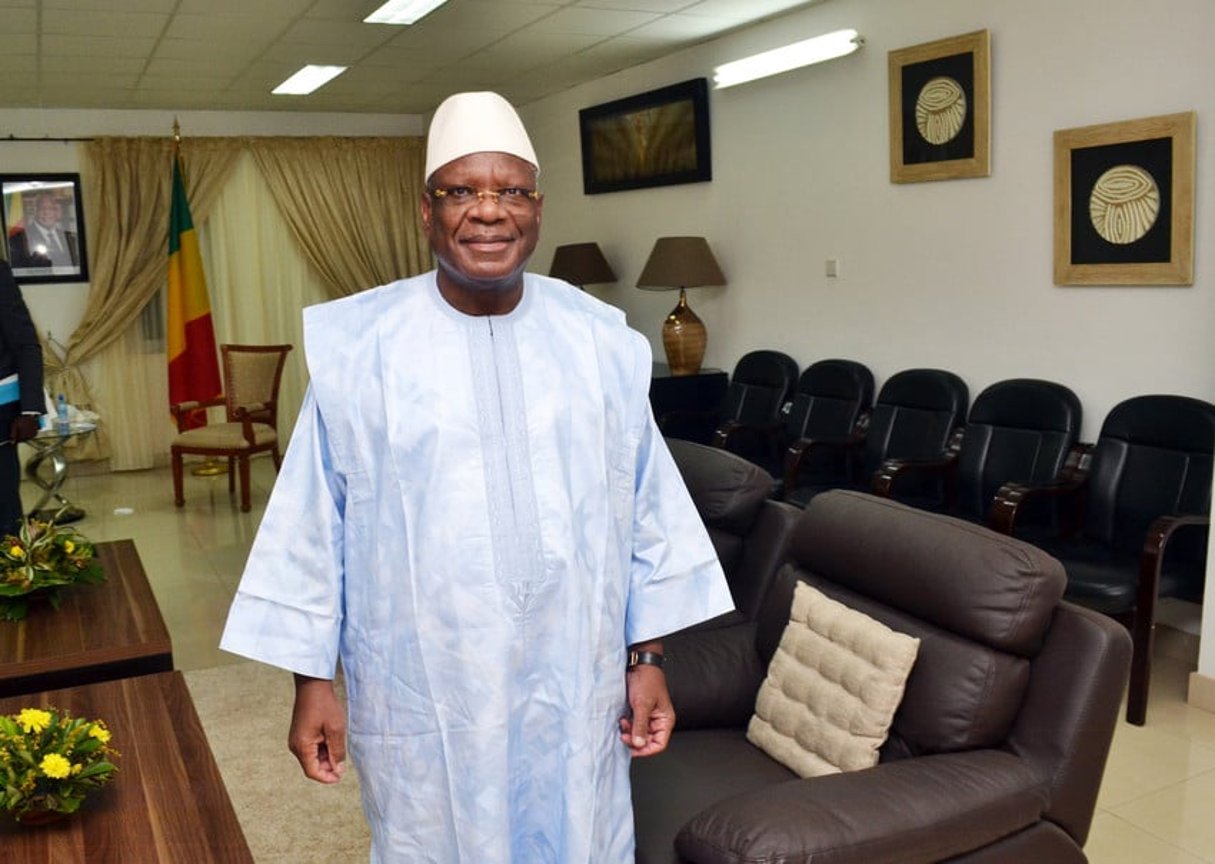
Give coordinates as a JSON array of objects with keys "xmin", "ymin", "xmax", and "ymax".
[{"xmin": 0, "ymin": 540, "xmax": 173, "ymax": 696}]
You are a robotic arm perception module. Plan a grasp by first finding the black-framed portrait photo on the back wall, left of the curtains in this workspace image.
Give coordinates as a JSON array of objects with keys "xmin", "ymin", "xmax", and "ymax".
[{"xmin": 0, "ymin": 174, "xmax": 89, "ymax": 284}]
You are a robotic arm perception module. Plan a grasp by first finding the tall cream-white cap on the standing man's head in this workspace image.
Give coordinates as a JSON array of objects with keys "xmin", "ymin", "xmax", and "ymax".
[{"xmin": 426, "ymin": 91, "xmax": 539, "ymax": 180}]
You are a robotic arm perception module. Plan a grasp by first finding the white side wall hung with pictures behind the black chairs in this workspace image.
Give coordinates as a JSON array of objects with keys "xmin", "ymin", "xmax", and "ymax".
[{"xmin": 524, "ymin": 0, "xmax": 1215, "ymax": 676}]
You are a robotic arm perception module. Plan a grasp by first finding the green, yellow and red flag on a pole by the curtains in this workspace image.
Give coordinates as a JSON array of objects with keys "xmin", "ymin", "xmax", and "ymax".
[{"xmin": 168, "ymin": 157, "xmax": 224, "ymax": 427}]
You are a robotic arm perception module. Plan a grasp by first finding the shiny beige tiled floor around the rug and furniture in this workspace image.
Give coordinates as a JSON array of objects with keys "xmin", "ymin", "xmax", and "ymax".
[{"xmin": 35, "ymin": 459, "xmax": 1215, "ymax": 864}]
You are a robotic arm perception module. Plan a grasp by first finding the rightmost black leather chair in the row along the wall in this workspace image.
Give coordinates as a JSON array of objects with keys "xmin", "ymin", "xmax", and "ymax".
[{"xmin": 993, "ymin": 395, "xmax": 1215, "ymax": 725}]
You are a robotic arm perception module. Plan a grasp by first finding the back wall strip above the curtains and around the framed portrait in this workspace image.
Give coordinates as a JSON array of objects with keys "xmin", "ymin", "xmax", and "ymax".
[{"xmin": 0, "ymin": 108, "xmax": 424, "ymax": 345}]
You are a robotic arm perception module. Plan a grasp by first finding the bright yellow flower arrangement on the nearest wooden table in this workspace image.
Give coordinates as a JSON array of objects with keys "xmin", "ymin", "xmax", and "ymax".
[{"xmin": 0, "ymin": 708, "xmax": 118, "ymax": 820}]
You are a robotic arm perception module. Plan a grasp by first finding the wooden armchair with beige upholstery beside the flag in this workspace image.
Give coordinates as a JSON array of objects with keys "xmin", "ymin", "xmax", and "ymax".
[{"xmin": 169, "ymin": 345, "xmax": 292, "ymax": 513}]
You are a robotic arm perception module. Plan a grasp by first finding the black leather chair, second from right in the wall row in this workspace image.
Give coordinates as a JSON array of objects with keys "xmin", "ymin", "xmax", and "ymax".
[{"xmin": 874, "ymin": 378, "xmax": 1083, "ymax": 523}]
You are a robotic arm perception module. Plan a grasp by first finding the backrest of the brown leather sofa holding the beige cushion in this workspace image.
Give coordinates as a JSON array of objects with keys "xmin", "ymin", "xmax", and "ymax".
[{"xmin": 757, "ymin": 490, "xmax": 1066, "ymax": 761}]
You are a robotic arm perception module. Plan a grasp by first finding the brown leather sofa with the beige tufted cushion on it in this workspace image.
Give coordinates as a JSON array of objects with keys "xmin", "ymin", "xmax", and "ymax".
[{"xmin": 632, "ymin": 491, "xmax": 1130, "ymax": 864}]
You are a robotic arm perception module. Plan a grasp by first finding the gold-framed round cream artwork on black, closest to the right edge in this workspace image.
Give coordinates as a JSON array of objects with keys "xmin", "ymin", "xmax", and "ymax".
[{"xmin": 1055, "ymin": 111, "xmax": 1197, "ymax": 286}]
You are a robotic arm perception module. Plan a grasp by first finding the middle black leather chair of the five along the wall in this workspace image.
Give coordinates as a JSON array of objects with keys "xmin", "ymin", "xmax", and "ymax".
[{"xmin": 784, "ymin": 369, "xmax": 970, "ymax": 507}]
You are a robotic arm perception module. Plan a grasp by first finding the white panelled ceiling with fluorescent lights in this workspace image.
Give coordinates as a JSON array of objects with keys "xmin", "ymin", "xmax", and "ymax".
[{"xmin": 0, "ymin": 0, "xmax": 815, "ymax": 114}]
